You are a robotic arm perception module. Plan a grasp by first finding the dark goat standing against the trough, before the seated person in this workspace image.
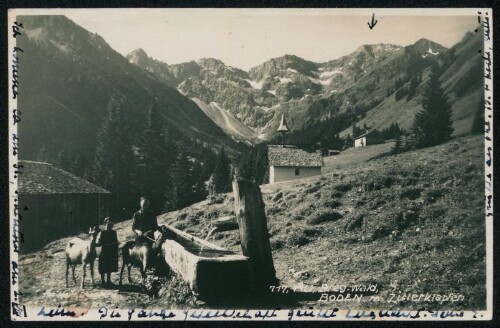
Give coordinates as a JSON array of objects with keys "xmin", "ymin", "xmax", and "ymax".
[{"xmin": 119, "ymin": 232, "xmax": 165, "ymax": 286}]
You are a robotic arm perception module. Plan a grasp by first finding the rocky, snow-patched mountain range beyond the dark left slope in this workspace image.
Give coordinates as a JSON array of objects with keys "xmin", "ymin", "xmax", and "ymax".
[{"xmin": 126, "ymin": 33, "xmax": 482, "ymax": 142}]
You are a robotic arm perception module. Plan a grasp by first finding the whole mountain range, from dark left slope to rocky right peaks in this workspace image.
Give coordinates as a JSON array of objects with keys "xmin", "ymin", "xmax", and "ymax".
[{"xmin": 17, "ymin": 16, "xmax": 483, "ymax": 168}]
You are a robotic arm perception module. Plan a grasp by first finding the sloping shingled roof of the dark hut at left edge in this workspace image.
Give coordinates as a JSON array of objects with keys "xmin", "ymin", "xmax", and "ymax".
[{"xmin": 18, "ymin": 160, "xmax": 109, "ymax": 194}]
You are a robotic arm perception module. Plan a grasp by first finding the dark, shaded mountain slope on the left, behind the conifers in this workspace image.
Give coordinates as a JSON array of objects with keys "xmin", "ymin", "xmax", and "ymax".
[{"xmin": 17, "ymin": 16, "xmax": 237, "ymax": 169}]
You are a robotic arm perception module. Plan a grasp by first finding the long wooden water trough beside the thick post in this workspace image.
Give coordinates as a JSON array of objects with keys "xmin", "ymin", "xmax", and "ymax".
[{"xmin": 162, "ymin": 225, "xmax": 250, "ymax": 299}]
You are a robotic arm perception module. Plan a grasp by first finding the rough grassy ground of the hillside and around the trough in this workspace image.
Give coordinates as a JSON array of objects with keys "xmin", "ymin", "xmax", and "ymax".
[{"xmin": 20, "ymin": 137, "xmax": 486, "ymax": 310}]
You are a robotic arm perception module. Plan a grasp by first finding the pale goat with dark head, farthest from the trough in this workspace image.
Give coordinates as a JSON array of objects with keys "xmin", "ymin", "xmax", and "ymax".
[{"xmin": 66, "ymin": 227, "xmax": 99, "ymax": 289}]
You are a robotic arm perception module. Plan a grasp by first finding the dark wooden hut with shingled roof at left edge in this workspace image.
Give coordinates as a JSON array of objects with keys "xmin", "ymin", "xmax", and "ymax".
[{"xmin": 18, "ymin": 160, "xmax": 110, "ymax": 253}]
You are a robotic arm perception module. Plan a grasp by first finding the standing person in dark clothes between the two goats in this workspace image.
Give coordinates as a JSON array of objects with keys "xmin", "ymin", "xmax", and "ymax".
[{"xmin": 96, "ymin": 217, "xmax": 118, "ymax": 285}]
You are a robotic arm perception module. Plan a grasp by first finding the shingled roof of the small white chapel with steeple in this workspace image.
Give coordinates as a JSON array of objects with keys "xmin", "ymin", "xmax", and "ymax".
[{"xmin": 267, "ymin": 145, "xmax": 323, "ymax": 167}]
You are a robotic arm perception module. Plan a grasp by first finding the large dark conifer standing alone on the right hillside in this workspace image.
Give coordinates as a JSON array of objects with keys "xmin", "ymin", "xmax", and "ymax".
[{"xmin": 412, "ymin": 69, "xmax": 453, "ymax": 148}]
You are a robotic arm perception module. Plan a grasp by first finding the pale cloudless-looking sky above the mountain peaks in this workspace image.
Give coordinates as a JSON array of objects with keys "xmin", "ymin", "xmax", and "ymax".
[{"xmin": 17, "ymin": 9, "xmax": 478, "ymax": 70}]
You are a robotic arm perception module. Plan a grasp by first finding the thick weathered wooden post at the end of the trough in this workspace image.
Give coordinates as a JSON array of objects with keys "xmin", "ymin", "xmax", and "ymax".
[{"xmin": 233, "ymin": 179, "xmax": 279, "ymax": 291}]
